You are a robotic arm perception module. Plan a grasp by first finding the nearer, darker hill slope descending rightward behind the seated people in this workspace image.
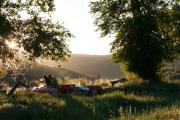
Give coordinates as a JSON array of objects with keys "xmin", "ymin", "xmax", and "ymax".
[{"xmin": 25, "ymin": 65, "xmax": 87, "ymax": 80}]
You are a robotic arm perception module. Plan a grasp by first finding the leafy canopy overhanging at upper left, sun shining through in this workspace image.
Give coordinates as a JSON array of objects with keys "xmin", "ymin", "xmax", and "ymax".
[{"xmin": 0, "ymin": 0, "xmax": 72, "ymax": 60}]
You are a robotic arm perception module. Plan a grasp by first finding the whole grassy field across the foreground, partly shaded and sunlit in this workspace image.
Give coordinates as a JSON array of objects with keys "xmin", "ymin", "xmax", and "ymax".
[{"xmin": 0, "ymin": 79, "xmax": 180, "ymax": 120}]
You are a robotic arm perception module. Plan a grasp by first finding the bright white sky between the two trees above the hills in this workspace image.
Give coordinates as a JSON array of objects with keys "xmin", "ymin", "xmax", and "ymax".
[{"xmin": 53, "ymin": 0, "xmax": 112, "ymax": 55}]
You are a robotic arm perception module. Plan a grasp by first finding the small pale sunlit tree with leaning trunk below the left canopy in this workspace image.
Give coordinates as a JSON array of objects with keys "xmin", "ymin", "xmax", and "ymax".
[{"xmin": 0, "ymin": 49, "xmax": 35, "ymax": 96}]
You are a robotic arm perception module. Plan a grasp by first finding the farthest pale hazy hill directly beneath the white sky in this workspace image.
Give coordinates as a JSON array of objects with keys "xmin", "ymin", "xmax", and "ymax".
[{"xmin": 61, "ymin": 54, "xmax": 122, "ymax": 79}]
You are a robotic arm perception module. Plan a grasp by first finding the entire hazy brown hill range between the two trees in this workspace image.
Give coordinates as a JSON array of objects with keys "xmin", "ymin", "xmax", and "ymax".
[{"xmin": 23, "ymin": 54, "xmax": 122, "ymax": 80}]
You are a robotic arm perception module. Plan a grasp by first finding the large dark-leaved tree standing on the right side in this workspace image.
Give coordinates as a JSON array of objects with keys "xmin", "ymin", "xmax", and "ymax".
[{"xmin": 90, "ymin": 0, "xmax": 180, "ymax": 81}]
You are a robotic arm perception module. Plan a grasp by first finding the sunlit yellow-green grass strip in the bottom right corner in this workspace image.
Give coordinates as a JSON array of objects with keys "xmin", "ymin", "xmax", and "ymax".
[{"xmin": 111, "ymin": 105, "xmax": 180, "ymax": 120}]
